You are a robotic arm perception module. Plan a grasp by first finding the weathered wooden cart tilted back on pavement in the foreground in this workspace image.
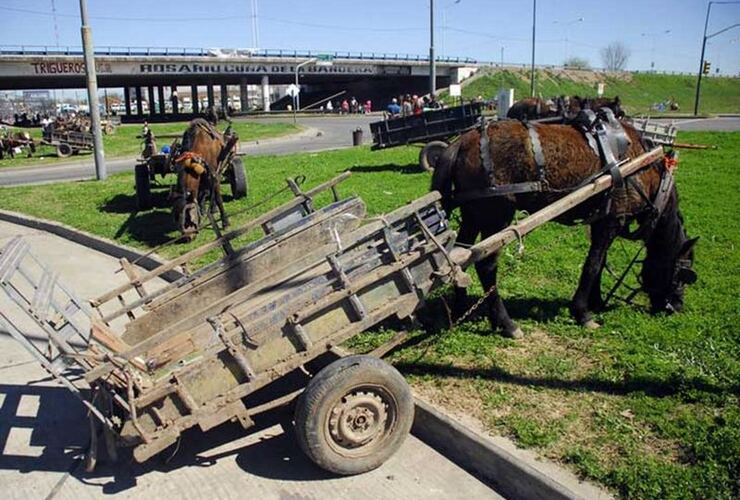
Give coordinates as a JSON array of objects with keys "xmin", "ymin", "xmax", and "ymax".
[{"xmin": 0, "ymin": 175, "xmax": 462, "ymax": 474}]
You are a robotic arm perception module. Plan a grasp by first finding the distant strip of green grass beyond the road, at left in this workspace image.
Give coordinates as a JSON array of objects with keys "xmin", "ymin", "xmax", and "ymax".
[{"xmin": 0, "ymin": 120, "xmax": 299, "ymax": 168}]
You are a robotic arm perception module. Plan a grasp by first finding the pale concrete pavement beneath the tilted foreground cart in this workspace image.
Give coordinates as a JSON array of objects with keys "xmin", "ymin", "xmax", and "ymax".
[{"xmin": 0, "ymin": 222, "xmax": 501, "ymax": 500}]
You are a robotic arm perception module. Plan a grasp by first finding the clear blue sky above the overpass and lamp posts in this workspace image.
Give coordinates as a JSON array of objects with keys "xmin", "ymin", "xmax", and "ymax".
[{"xmin": 0, "ymin": 0, "xmax": 740, "ymax": 75}]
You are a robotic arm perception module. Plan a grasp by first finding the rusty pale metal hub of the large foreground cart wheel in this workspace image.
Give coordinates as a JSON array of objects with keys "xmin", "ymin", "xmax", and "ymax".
[{"xmin": 329, "ymin": 391, "xmax": 388, "ymax": 449}]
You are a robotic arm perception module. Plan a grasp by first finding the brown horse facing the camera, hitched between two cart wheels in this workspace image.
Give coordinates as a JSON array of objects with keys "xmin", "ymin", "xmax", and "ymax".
[{"xmin": 170, "ymin": 118, "xmax": 229, "ymax": 240}]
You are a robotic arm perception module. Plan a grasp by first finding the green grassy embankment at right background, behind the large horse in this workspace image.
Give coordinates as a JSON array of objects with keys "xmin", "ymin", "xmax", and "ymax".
[{"xmin": 448, "ymin": 70, "xmax": 740, "ymax": 115}]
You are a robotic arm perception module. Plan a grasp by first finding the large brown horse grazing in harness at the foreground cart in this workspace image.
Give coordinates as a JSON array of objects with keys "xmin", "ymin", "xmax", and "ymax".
[{"xmin": 432, "ymin": 114, "xmax": 696, "ymax": 337}]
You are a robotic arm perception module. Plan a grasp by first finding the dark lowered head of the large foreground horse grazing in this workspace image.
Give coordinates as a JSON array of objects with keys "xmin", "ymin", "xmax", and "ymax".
[{"xmin": 641, "ymin": 187, "xmax": 699, "ymax": 313}]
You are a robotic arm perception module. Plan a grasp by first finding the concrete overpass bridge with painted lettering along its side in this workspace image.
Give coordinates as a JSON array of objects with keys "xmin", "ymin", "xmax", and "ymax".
[{"xmin": 0, "ymin": 46, "xmax": 477, "ymax": 119}]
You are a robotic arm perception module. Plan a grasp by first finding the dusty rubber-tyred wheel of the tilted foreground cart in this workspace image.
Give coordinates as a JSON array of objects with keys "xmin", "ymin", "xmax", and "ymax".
[{"xmin": 295, "ymin": 356, "xmax": 414, "ymax": 475}]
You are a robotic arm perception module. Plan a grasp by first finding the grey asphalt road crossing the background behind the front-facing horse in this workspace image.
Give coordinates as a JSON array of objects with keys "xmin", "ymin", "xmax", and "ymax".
[{"xmin": 0, "ymin": 115, "xmax": 380, "ymax": 186}]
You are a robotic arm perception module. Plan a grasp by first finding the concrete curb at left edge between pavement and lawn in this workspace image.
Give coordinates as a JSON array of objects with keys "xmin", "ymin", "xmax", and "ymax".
[{"xmin": 0, "ymin": 210, "xmax": 183, "ymax": 281}]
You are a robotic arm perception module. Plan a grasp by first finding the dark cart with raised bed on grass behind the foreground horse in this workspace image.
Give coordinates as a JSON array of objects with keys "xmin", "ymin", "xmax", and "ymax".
[{"xmin": 370, "ymin": 103, "xmax": 483, "ymax": 171}]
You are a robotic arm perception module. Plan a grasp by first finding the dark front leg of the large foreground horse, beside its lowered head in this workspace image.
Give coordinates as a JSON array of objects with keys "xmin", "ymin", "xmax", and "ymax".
[{"xmin": 571, "ymin": 218, "xmax": 619, "ymax": 328}]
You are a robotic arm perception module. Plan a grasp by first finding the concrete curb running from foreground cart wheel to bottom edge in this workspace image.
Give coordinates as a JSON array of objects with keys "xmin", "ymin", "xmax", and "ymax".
[{"xmin": 412, "ymin": 398, "xmax": 608, "ymax": 500}]
